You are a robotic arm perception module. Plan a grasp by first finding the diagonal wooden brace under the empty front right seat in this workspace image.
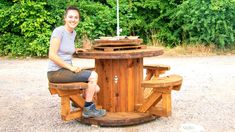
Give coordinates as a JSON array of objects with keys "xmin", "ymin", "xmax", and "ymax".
[{"xmin": 138, "ymin": 92, "xmax": 162, "ymax": 112}]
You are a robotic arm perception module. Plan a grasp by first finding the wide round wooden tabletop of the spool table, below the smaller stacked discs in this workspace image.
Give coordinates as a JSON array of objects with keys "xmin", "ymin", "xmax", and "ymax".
[{"xmin": 74, "ymin": 47, "xmax": 164, "ymax": 59}]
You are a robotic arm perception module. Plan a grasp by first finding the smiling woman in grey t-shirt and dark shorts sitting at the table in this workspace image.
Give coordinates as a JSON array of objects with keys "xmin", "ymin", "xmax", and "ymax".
[{"xmin": 47, "ymin": 6, "xmax": 106, "ymax": 118}]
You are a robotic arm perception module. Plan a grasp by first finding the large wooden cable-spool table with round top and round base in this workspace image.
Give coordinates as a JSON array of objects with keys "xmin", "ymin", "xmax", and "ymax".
[{"xmin": 74, "ymin": 41, "xmax": 163, "ymax": 126}]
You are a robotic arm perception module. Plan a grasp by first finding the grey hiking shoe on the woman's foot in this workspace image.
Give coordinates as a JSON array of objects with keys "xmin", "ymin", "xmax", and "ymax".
[{"xmin": 82, "ymin": 104, "xmax": 106, "ymax": 118}]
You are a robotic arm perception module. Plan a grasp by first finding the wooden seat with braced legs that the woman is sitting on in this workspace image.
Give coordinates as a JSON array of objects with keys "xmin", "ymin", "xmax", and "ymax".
[{"xmin": 49, "ymin": 82, "xmax": 88, "ymax": 121}]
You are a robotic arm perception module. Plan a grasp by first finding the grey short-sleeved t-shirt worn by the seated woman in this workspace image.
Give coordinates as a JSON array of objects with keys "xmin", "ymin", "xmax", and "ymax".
[{"xmin": 47, "ymin": 26, "xmax": 76, "ymax": 71}]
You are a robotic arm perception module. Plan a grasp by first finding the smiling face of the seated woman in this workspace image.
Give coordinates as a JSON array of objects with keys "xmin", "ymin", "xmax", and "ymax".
[{"xmin": 64, "ymin": 10, "xmax": 79, "ymax": 32}]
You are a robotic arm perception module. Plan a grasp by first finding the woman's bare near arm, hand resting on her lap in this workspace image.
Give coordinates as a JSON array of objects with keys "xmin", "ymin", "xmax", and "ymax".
[{"xmin": 49, "ymin": 38, "xmax": 81, "ymax": 72}]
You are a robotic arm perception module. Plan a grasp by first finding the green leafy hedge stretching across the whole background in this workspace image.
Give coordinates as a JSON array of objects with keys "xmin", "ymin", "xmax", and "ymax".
[{"xmin": 0, "ymin": 0, "xmax": 235, "ymax": 57}]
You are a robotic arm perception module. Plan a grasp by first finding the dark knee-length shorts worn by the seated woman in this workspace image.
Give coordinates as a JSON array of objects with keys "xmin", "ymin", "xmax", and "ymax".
[{"xmin": 47, "ymin": 68, "xmax": 92, "ymax": 83}]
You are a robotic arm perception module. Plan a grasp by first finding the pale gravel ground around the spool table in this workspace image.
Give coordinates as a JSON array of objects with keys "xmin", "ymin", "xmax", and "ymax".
[{"xmin": 0, "ymin": 55, "xmax": 235, "ymax": 132}]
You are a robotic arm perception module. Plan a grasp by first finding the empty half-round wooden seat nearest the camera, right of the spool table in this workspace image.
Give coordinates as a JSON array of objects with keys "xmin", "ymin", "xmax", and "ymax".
[{"xmin": 138, "ymin": 75, "xmax": 183, "ymax": 116}]
